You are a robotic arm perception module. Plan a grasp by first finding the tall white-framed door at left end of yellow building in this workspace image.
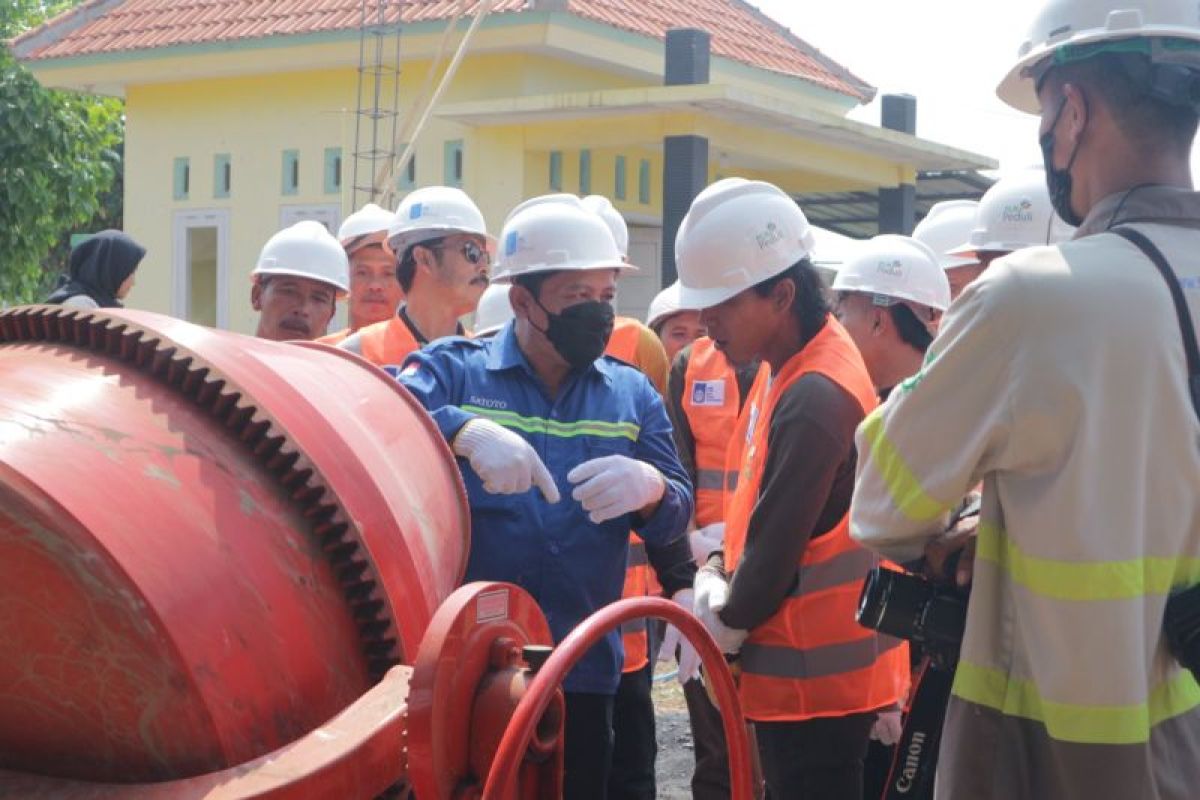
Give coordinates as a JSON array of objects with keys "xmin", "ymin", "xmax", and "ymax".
[{"xmin": 170, "ymin": 209, "xmax": 229, "ymax": 327}]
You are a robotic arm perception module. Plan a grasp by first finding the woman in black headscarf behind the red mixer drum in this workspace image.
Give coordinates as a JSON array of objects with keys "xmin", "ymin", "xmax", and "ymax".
[{"xmin": 46, "ymin": 230, "xmax": 146, "ymax": 309}]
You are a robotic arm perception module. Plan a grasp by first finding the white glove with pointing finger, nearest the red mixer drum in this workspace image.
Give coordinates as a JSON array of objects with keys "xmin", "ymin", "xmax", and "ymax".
[{"xmin": 454, "ymin": 417, "xmax": 559, "ymax": 503}]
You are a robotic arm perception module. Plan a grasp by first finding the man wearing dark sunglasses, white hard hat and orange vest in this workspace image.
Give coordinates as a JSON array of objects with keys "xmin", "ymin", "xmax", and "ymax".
[{"xmin": 340, "ymin": 186, "xmax": 494, "ymax": 367}]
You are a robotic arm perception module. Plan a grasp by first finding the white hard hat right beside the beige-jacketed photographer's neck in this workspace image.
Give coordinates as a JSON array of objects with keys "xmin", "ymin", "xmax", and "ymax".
[{"xmin": 950, "ymin": 167, "xmax": 1075, "ymax": 259}]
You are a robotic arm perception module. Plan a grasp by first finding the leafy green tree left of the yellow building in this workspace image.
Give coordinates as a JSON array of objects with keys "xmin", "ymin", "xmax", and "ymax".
[{"xmin": 0, "ymin": 0, "xmax": 125, "ymax": 305}]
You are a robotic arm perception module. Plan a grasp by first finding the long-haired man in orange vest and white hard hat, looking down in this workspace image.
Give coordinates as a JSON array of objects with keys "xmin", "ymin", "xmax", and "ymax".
[{"xmin": 676, "ymin": 179, "xmax": 908, "ymax": 800}]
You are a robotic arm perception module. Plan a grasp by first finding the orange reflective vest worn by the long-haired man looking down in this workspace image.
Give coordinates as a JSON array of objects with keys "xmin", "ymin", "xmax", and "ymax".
[{"xmin": 725, "ymin": 317, "xmax": 908, "ymax": 721}]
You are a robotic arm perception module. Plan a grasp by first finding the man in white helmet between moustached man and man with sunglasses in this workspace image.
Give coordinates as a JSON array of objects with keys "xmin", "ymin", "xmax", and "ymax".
[{"xmin": 317, "ymin": 203, "xmax": 404, "ymax": 344}]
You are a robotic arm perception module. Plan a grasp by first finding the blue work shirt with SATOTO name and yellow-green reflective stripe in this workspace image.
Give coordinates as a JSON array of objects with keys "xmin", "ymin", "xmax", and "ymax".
[{"xmin": 400, "ymin": 323, "xmax": 692, "ymax": 694}]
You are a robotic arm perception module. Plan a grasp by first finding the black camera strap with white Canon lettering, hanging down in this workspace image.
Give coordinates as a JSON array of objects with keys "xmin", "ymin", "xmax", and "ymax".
[{"xmin": 882, "ymin": 656, "xmax": 954, "ymax": 800}]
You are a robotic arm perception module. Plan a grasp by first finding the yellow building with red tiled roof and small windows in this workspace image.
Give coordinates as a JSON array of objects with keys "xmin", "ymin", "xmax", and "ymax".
[{"xmin": 13, "ymin": 0, "xmax": 995, "ymax": 332}]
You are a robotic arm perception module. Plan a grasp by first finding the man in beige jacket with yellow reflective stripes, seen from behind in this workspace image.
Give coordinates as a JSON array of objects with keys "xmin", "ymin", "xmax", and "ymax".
[{"xmin": 851, "ymin": 0, "xmax": 1200, "ymax": 800}]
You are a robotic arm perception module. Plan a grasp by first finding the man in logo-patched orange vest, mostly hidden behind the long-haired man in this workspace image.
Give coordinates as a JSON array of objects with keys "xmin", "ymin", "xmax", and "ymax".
[{"xmin": 646, "ymin": 282, "xmax": 758, "ymax": 800}]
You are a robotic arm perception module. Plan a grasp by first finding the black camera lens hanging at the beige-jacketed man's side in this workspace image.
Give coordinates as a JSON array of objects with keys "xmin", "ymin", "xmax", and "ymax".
[{"xmin": 856, "ymin": 566, "xmax": 969, "ymax": 667}]
